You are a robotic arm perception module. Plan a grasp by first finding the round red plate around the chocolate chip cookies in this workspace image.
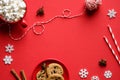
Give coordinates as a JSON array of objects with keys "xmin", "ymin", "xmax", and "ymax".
[{"xmin": 32, "ymin": 59, "xmax": 69, "ymax": 80}]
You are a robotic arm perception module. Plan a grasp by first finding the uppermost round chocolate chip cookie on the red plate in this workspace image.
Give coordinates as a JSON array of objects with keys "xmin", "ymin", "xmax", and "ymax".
[{"xmin": 47, "ymin": 63, "xmax": 64, "ymax": 76}]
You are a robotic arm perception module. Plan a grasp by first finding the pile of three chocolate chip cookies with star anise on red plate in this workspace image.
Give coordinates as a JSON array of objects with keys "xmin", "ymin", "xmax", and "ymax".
[{"xmin": 36, "ymin": 63, "xmax": 64, "ymax": 80}]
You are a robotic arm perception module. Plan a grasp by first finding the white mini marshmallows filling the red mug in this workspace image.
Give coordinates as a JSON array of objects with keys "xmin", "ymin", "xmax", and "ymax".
[{"xmin": 0, "ymin": 0, "xmax": 26, "ymax": 23}]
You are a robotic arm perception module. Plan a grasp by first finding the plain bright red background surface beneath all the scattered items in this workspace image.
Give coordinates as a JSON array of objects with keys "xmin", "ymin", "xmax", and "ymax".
[{"xmin": 0, "ymin": 0, "xmax": 120, "ymax": 80}]
